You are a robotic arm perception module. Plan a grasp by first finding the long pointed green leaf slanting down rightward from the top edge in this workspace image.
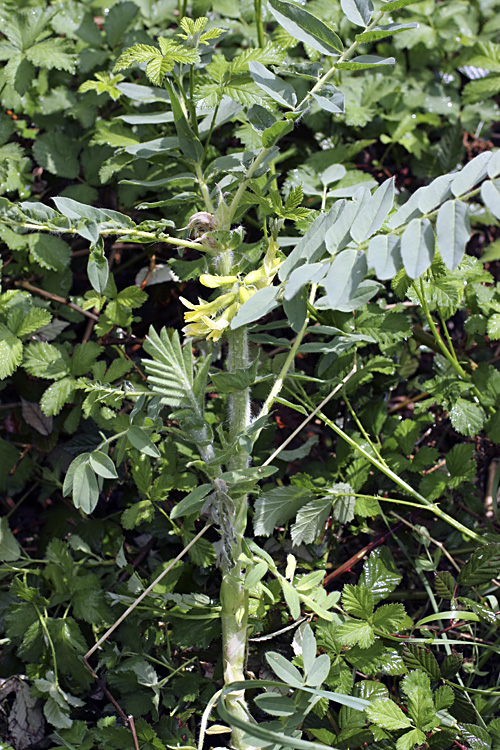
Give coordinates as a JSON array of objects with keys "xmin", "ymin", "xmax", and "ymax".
[{"xmin": 269, "ymin": 0, "xmax": 344, "ymax": 55}]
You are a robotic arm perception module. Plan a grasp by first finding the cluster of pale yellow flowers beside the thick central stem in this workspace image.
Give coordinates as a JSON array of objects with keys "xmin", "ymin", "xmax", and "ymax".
[{"xmin": 180, "ymin": 239, "xmax": 282, "ymax": 341}]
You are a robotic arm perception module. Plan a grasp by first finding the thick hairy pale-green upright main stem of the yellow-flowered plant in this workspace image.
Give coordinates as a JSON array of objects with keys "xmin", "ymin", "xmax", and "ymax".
[{"xmin": 218, "ymin": 251, "xmax": 254, "ymax": 750}]
